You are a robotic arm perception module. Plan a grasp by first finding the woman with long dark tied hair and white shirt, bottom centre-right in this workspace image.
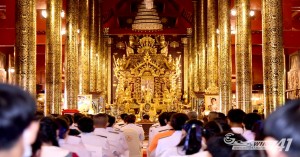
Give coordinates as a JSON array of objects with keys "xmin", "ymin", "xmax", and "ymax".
[{"xmin": 160, "ymin": 119, "xmax": 208, "ymax": 157}]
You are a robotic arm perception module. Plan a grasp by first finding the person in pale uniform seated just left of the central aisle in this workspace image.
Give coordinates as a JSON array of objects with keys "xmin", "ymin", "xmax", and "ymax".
[{"xmin": 121, "ymin": 114, "xmax": 145, "ymax": 142}]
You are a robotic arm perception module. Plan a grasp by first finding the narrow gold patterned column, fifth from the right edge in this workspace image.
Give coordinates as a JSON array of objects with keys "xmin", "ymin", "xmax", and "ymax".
[{"xmin": 197, "ymin": 0, "xmax": 206, "ymax": 92}]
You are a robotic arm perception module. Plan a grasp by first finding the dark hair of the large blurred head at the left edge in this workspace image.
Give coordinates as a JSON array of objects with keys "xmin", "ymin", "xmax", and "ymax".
[{"xmin": 0, "ymin": 84, "xmax": 36, "ymax": 151}]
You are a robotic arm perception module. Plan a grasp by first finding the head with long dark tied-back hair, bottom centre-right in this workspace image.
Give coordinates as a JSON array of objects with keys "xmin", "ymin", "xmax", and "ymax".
[{"xmin": 178, "ymin": 119, "xmax": 203, "ymax": 155}]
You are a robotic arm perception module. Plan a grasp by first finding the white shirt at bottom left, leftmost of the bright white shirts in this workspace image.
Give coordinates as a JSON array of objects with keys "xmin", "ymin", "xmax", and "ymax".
[{"xmin": 58, "ymin": 136, "xmax": 91, "ymax": 157}]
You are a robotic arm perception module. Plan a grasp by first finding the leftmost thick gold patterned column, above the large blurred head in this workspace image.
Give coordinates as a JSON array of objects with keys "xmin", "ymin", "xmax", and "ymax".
[{"xmin": 15, "ymin": 0, "xmax": 36, "ymax": 96}]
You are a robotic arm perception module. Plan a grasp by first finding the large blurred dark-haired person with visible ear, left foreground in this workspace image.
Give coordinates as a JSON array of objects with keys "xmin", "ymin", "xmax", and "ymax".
[{"xmin": 0, "ymin": 84, "xmax": 39, "ymax": 157}]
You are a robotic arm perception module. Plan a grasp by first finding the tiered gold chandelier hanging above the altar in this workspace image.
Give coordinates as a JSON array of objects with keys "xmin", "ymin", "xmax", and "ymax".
[{"xmin": 132, "ymin": 0, "xmax": 163, "ymax": 31}]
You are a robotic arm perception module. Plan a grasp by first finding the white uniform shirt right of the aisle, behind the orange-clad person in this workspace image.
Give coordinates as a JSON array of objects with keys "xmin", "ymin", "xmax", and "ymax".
[{"xmin": 155, "ymin": 130, "xmax": 182, "ymax": 157}]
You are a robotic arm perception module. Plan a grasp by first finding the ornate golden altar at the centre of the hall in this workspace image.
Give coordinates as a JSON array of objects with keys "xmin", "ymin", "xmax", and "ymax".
[{"xmin": 113, "ymin": 36, "xmax": 182, "ymax": 118}]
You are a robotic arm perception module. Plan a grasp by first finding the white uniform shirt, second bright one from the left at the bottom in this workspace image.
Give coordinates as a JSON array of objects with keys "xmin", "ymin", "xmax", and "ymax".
[{"xmin": 80, "ymin": 132, "xmax": 113, "ymax": 157}]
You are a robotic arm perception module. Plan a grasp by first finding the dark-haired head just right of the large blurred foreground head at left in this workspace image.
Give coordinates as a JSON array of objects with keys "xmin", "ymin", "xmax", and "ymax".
[{"xmin": 37, "ymin": 117, "xmax": 58, "ymax": 146}]
